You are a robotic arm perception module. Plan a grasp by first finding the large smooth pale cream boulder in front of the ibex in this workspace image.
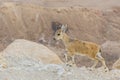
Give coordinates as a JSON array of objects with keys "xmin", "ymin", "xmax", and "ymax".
[{"xmin": 1, "ymin": 39, "xmax": 62, "ymax": 66}]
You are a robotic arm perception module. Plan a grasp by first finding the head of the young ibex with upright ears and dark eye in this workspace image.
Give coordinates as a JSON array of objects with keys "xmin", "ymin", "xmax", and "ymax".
[{"xmin": 54, "ymin": 24, "xmax": 67, "ymax": 40}]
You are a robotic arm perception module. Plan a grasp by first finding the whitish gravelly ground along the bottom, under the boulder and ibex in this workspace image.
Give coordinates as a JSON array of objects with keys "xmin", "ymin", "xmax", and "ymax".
[{"xmin": 0, "ymin": 62, "xmax": 120, "ymax": 80}]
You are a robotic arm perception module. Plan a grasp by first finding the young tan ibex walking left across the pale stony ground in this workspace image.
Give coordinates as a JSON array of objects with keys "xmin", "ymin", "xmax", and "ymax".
[{"xmin": 54, "ymin": 25, "xmax": 107, "ymax": 69}]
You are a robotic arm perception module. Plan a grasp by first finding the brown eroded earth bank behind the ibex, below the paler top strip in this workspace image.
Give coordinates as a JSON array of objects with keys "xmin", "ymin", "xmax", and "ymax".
[{"xmin": 0, "ymin": 2, "xmax": 120, "ymax": 50}]
